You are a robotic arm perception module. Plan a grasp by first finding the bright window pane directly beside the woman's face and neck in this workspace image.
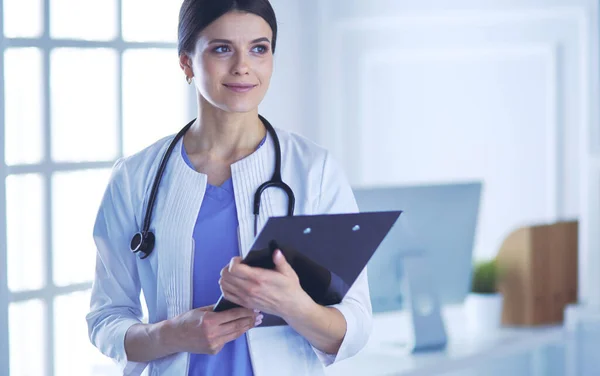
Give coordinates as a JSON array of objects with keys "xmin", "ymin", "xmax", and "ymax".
[{"xmin": 123, "ymin": 49, "xmax": 191, "ymax": 155}]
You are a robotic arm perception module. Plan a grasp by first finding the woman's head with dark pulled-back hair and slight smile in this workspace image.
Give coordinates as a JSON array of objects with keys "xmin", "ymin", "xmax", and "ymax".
[{"xmin": 179, "ymin": 1, "xmax": 277, "ymax": 117}]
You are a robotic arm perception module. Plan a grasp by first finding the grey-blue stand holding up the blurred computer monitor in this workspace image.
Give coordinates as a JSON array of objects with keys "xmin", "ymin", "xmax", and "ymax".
[{"xmin": 401, "ymin": 252, "xmax": 448, "ymax": 353}]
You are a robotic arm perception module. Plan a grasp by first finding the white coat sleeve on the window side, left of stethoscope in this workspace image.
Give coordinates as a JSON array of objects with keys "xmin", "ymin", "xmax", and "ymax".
[{"xmin": 86, "ymin": 160, "xmax": 146, "ymax": 376}]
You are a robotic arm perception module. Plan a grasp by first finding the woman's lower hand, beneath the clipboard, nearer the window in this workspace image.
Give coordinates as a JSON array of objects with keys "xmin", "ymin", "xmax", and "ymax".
[{"xmin": 169, "ymin": 306, "xmax": 263, "ymax": 355}]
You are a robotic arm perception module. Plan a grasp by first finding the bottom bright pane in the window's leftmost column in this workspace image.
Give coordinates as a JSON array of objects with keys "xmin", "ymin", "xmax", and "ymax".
[{"xmin": 8, "ymin": 300, "xmax": 47, "ymax": 376}]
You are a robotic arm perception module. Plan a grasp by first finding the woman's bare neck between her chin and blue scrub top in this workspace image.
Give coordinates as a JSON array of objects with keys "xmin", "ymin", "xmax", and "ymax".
[{"xmin": 184, "ymin": 98, "xmax": 266, "ymax": 160}]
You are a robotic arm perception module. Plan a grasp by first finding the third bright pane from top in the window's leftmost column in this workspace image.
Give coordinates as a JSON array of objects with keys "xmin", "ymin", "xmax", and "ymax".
[{"xmin": 6, "ymin": 174, "xmax": 46, "ymax": 292}]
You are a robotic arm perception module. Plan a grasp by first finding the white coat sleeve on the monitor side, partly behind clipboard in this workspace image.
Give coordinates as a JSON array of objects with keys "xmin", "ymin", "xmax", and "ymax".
[{"xmin": 313, "ymin": 154, "xmax": 373, "ymax": 366}]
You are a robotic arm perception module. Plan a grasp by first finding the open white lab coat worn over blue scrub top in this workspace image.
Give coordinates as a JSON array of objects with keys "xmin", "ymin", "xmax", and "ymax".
[{"xmin": 86, "ymin": 129, "xmax": 372, "ymax": 376}]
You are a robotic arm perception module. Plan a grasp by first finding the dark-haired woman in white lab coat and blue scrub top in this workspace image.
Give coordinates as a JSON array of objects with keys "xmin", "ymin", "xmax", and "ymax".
[{"xmin": 87, "ymin": 0, "xmax": 372, "ymax": 376}]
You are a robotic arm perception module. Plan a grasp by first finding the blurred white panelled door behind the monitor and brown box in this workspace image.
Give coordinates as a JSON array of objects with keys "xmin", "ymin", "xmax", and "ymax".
[{"xmin": 318, "ymin": 0, "xmax": 597, "ymax": 302}]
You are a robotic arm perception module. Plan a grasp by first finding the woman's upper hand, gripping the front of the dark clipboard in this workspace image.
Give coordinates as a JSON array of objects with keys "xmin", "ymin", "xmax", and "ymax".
[{"xmin": 219, "ymin": 250, "xmax": 310, "ymax": 319}]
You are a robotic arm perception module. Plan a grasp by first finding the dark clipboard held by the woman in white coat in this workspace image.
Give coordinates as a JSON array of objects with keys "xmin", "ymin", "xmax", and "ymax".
[{"xmin": 213, "ymin": 211, "xmax": 402, "ymax": 326}]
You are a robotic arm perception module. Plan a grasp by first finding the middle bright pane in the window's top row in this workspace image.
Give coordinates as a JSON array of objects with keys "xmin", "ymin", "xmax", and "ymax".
[{"xmin": 50, "ymin": 0, "xmax": 117, "ymax": 41}]
